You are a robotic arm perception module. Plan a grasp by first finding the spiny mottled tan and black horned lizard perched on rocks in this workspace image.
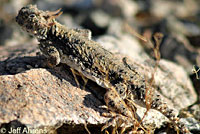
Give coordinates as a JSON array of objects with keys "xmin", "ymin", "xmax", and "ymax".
[{"xmin": 16, "ymin": 5, "xmax": 188, "ymax": 133}]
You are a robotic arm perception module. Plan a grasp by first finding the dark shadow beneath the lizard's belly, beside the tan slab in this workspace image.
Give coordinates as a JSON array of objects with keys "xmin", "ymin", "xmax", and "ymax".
[{"xmin": 48, "ymin": 63, "xmax": 106, "ymax": 114}]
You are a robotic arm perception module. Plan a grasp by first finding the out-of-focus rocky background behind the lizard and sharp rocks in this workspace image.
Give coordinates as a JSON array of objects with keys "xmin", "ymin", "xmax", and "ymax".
[{"xmin": 0, "ymin": 0, "xmax": 200, "ymax": 89}]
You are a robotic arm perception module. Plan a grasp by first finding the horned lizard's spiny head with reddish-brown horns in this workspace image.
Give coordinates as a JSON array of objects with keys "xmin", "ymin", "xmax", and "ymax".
[{"xmin": 16, "ymin": 5, "xmax": 62, "ymax": 36}]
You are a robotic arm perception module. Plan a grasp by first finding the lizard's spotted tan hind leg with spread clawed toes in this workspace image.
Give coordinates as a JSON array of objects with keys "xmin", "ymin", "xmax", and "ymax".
[{"xmin": 102, "ymin": 87, "xmax": 138, "ymax": 133}]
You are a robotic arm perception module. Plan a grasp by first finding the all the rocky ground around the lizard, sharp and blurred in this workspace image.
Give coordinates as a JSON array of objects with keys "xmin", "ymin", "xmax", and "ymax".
[{"xmin": 0, "ymin": 0, "xmax": 200, "ymax": 134}]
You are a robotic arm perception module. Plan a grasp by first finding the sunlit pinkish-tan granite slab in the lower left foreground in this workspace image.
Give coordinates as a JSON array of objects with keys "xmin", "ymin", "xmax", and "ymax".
[{"xmin": 0, "ymin": 69, "xmax": 105, "ymax": 133}]
